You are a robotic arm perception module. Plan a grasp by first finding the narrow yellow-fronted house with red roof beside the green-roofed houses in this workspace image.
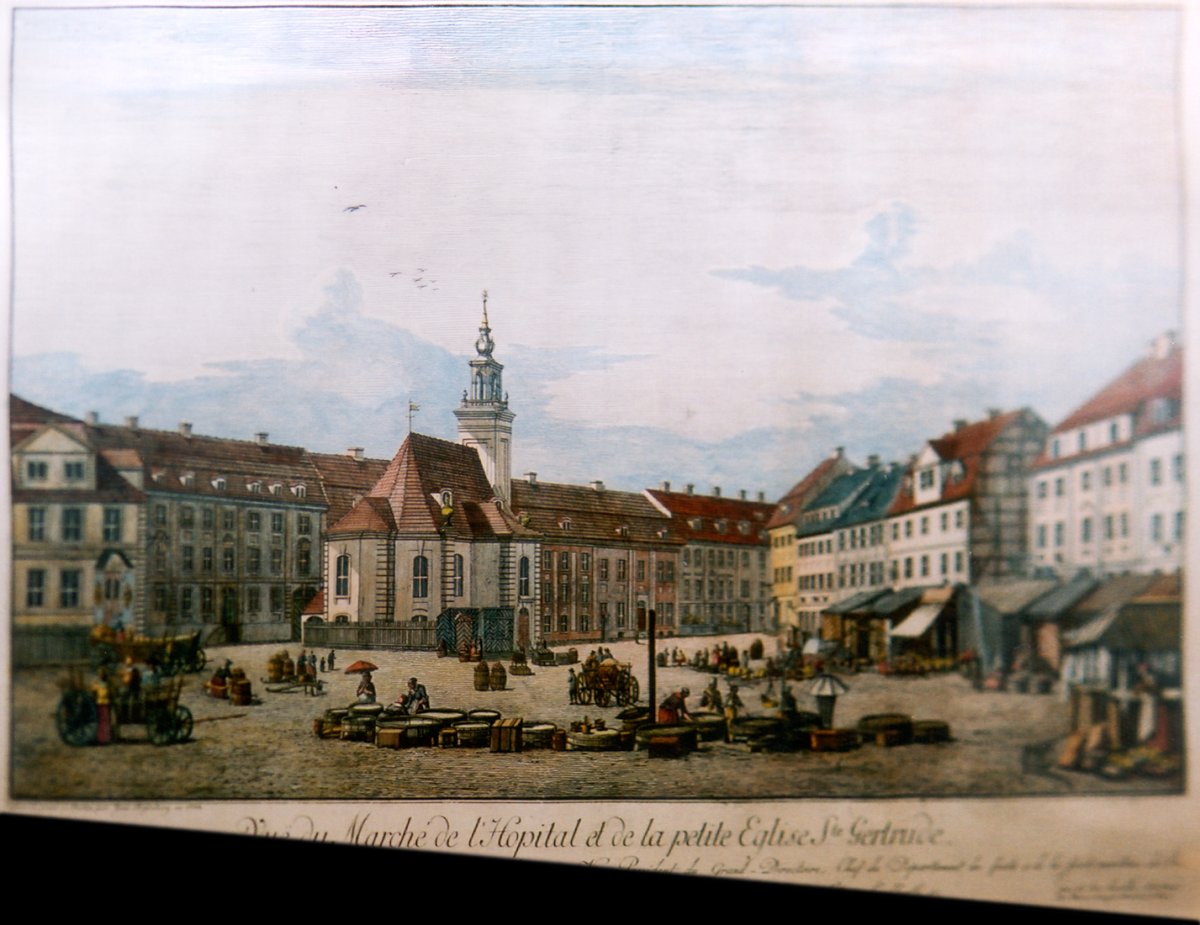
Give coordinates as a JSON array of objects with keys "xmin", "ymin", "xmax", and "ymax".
[{"xmin": 767, "ymin": 446, "xmax": 853, "ymax": 645}]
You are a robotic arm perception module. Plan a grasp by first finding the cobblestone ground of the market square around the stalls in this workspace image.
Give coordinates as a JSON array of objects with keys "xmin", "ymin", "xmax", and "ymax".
[{"xmin": 10, "ymin": 636, "xmax": 1180, "ymax": 800}]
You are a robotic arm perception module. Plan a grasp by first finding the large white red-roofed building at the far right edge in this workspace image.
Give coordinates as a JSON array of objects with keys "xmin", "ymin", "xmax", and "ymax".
[{"xmin": 1028, "ymin": 334, "xmax": 1186, "ymax": 576}]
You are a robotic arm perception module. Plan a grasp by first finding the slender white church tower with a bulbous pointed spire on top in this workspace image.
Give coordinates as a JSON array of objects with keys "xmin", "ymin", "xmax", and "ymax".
[{"xmin": 454, "ymin": 289, "xmax": 516, "ymax": 505}]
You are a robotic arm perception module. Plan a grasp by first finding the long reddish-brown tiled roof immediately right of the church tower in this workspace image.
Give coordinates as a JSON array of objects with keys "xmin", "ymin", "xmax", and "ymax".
[{"xmin": 512, "ymin": 480, "xmax": 683, "ymax": 546}]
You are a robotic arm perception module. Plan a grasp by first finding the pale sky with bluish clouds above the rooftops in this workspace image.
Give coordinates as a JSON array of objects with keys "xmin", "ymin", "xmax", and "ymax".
[{"xmin": 11, "ymin": 7, "xmax": 1182, "ymax": 499}]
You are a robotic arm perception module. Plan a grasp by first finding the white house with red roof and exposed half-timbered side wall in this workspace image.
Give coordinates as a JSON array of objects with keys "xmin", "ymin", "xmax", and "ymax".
[{"xmin": 884, "ymin": 408, "xmax": 1046, "ymax": 588}]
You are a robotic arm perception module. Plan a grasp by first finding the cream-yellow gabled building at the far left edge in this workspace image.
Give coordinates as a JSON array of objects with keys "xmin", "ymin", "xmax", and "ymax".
[{"xmin": 8, "ymin": 396, "xmax": 145, "ymax": 633}]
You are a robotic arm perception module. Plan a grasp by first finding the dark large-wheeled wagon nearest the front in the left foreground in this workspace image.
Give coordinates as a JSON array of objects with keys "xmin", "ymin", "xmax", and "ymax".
[{"xmin": 54, "ymin": 672, "xmax": 193, "ymax": 745}]
